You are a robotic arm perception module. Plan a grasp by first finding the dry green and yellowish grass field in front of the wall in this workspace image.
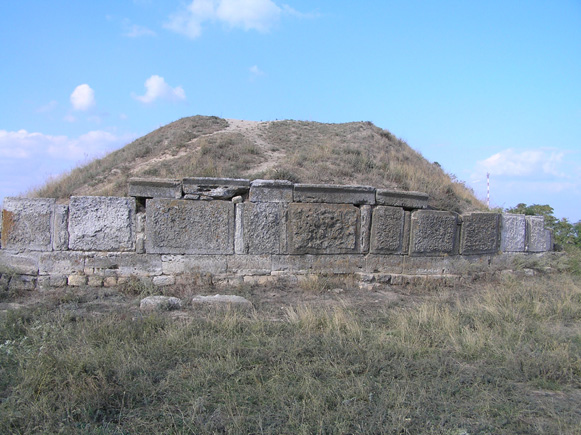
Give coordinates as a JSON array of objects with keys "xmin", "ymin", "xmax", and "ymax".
[{"xmin": 0, "ymin": 274, "xmax": 581, "ymax": 435}]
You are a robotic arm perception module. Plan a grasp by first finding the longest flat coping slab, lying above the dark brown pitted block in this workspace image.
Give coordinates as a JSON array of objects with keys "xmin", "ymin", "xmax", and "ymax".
[{"xmin": 294, "ymin": 184, "xmax": 375, "ymax": 205}]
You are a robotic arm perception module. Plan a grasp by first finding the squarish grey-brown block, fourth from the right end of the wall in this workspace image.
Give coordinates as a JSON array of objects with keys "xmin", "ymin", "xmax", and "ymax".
[{"xmin": 410, "ymin": 210, "xmax": 458, "ymax": 255}]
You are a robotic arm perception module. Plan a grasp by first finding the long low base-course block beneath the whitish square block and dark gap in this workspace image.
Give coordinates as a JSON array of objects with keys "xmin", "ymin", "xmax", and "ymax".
[{"xmin": 85, "ymin": 252, "xmax": 162, "ymax": 276}]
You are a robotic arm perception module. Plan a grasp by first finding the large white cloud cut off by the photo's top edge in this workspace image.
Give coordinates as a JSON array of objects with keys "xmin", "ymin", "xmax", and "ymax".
[{"xmin": 164, "ymin": 0, "xmax": 284, "ymax": 39}]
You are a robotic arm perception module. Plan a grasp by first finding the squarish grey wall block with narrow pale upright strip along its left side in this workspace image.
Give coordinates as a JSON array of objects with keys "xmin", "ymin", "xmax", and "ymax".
[{"xmin": 236, "ymin": 202, "xmax": 287, "ymax": 254}]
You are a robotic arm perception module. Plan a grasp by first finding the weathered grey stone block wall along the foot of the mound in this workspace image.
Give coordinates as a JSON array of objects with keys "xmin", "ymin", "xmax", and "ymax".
[{"xmin": 0, "ymin": 178, "xmax": 552, "ymax": 288}]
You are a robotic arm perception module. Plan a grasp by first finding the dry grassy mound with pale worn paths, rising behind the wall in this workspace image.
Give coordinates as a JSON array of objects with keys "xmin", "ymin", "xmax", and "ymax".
[{"xmin": 32, "ymin": 115, "xmax": 485, "ymax": 212}]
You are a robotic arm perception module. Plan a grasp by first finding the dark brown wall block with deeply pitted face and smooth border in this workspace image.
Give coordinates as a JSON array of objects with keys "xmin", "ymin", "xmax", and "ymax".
[{"xmin": 288, "ymin": 203, "xmax": 360, "ymax": 254}]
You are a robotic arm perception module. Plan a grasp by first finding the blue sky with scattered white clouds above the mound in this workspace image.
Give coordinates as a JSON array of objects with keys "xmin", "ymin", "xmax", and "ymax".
[{"xmin": 0, "ymin": 0, "xmax": 581, "ymax": 222}]
